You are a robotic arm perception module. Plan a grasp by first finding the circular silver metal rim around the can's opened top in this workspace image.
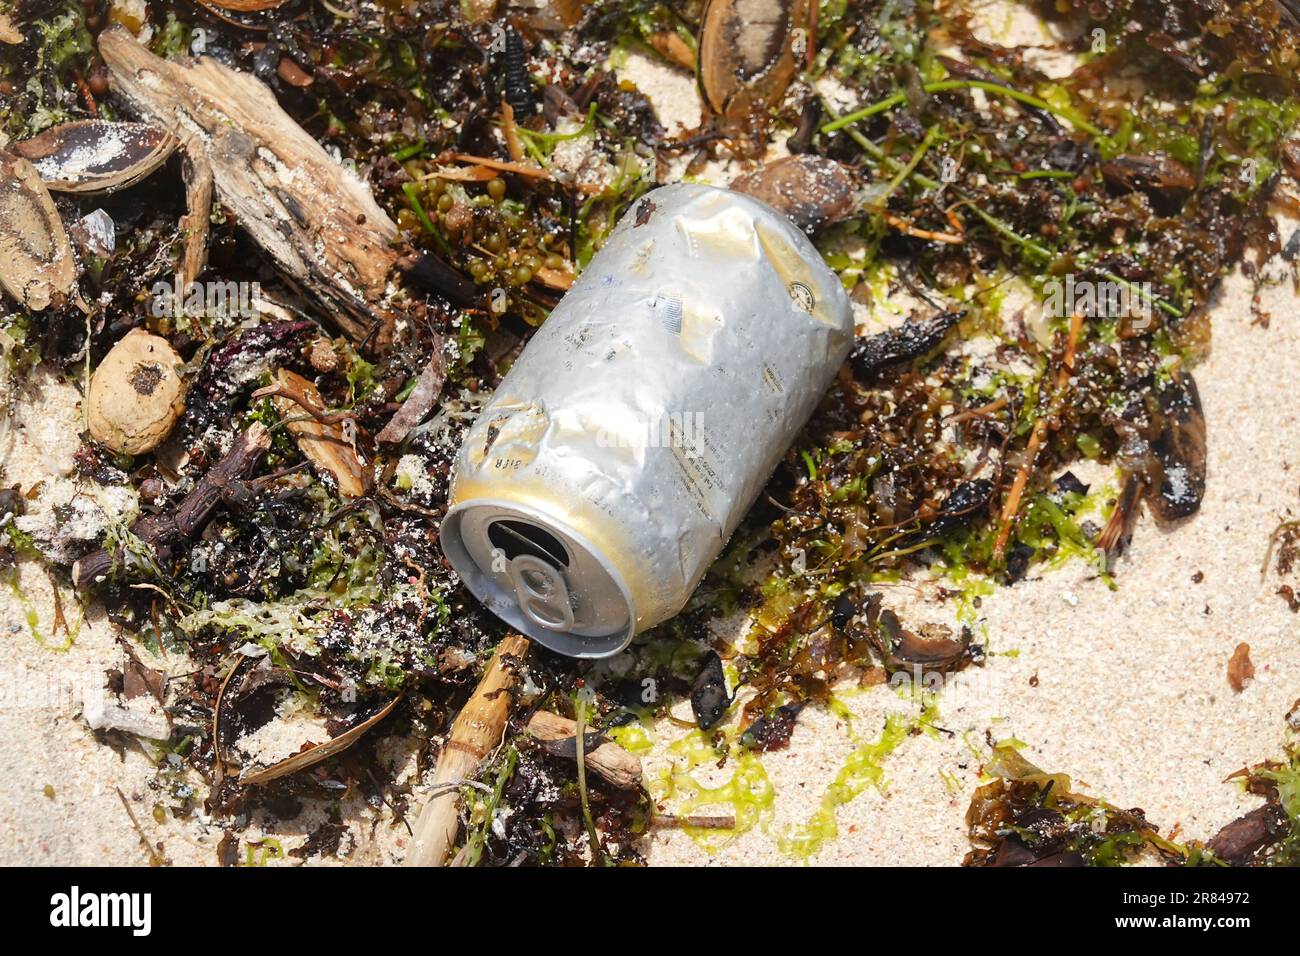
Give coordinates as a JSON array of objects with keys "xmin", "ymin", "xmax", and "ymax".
[{"xmin": 438, "ymin": 498, "xmax": 637, "ymax": 661}]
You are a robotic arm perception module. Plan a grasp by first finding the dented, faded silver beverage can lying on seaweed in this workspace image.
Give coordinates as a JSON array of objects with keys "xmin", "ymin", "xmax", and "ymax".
[{"xmin": 441, "ymin": 183, "xmax": 854, "ymax": 658}]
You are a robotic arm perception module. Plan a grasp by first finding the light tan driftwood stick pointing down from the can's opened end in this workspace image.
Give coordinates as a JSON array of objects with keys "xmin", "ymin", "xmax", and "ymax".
[{"xmin": 403, "ymin": 635, "xmax": 528, "ymax": 866}]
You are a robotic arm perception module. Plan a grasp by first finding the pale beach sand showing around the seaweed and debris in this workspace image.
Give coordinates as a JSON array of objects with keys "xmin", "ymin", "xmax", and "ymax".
[{"xmin": 0, "ymin": 7, "xmax": 1300, "ymax": 865}]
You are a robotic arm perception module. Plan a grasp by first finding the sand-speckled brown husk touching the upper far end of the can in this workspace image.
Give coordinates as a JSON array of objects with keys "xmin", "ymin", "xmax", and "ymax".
[{"xmin": 731, "ymin": 153, "xmax": 858, "ymax": 233}]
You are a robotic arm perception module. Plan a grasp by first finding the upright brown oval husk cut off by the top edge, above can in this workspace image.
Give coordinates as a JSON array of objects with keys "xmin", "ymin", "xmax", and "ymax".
[{"xmin": 699, "ymin": 0, "xmax": 809, "ymax": 117}]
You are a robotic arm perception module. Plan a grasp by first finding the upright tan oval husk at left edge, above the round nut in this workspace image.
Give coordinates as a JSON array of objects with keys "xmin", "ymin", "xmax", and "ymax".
[{"xmin": 0, "ymin": 151, "xmax": 77, "ymax": 312}]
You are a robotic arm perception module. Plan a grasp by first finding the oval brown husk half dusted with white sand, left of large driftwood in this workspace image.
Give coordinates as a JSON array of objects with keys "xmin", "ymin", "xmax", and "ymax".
[{"xmin": 13, "ymin": 120, "xmax": 178, "ymax": 193}]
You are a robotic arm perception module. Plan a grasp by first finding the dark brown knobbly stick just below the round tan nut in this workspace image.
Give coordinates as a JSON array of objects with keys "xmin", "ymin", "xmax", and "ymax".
[{"xmin": 73, "ymin": 421, "xmax": 270, "ymax": 588}]
